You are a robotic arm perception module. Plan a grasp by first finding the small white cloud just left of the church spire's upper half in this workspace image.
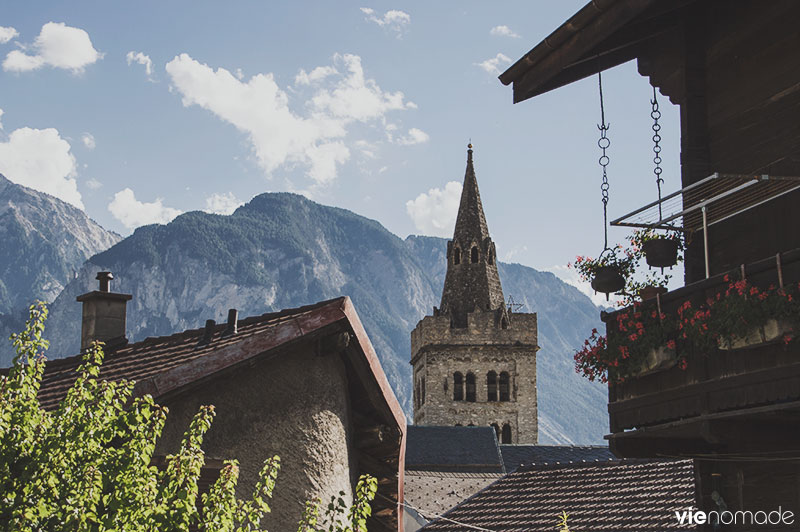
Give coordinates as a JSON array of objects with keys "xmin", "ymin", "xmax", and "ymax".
[{"xmin": 406, "ymin": 181, "xmax": 461, "ymax": 237}]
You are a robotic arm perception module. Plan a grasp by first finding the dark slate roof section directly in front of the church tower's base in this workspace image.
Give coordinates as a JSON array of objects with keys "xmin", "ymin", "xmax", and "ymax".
[{"xmin": 406, "ymin": 425, "xmax": 505, "ymax": 473}]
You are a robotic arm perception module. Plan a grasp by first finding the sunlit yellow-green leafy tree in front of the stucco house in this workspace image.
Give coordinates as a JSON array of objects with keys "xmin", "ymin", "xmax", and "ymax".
[{"xmin": 0, "ymin": 303, "xmax": 377, "ymax": 532}]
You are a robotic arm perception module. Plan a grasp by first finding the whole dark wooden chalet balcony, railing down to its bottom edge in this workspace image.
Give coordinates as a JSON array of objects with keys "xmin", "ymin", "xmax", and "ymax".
[{"xmin": 603, "ymin": 249, "xmax": 800, "ymax": 457}]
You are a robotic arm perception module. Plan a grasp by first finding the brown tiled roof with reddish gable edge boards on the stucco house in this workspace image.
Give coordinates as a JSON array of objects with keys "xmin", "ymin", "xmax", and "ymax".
[{"xmin": 23, "ymin": 297, "xmax": 406, "ymax": 529}]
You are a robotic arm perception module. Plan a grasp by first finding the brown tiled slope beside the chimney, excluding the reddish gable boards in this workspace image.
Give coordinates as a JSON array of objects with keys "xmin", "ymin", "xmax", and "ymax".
[{"xmin": 32, "ymin": 298, "xmax": 345, "ymax": 408}]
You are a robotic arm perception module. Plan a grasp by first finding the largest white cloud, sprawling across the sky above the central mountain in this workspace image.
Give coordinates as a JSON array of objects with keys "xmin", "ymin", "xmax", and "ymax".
[{"xmin": 166, "ymin": 50, "xmax": 410, "ymax": 185}]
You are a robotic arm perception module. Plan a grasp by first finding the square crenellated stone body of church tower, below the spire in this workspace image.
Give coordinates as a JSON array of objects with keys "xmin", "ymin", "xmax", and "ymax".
[{"xmin": 411, "ymin": 312, "xmax": 538, "ymax": 443}]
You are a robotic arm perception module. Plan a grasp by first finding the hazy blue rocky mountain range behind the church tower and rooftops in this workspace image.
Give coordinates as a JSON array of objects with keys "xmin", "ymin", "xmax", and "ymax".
[{"xmin": 0, "ymin": 180, "xmax": 607, "ymax": 444}]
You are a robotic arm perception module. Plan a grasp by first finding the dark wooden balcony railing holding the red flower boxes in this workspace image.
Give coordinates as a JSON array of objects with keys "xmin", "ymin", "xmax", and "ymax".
[{"xmin": 603, "ymin": 249, "xmax": 800, "ymax": 440}]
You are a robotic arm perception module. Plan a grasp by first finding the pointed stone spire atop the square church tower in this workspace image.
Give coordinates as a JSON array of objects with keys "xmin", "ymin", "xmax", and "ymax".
[{"xmin": 441, "ymin": 143, "xmax": 505, "ymax": 327}]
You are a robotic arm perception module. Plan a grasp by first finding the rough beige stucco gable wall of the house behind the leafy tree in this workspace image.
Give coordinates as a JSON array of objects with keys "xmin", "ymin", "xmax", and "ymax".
[{"xmin": 157, "ymin": 349, "xmax": 356, "ymax": 530}]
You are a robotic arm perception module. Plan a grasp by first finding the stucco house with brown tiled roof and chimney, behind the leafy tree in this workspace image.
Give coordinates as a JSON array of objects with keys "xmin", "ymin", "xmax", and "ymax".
[{"xmin": 35, "ymin": 272, "xmax": 406, "ymax": 532}]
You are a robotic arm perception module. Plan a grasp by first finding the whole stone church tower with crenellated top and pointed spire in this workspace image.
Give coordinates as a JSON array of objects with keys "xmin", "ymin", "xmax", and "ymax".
[{"xmin": 411, "ymin": 144, "xmax": 539, "ymax": 443}]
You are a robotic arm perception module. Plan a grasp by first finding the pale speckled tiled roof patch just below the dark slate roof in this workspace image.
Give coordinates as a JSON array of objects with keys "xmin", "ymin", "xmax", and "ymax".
[{"xmin": 403, "ymin": 470, "xmax": 503, "ymax": 521}]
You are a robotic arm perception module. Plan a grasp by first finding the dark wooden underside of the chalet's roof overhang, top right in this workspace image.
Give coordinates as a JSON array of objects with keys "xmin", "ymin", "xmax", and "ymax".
[{"xmin": 499, "ymin": 0, "xmax": 694, "ymax": 103}]
